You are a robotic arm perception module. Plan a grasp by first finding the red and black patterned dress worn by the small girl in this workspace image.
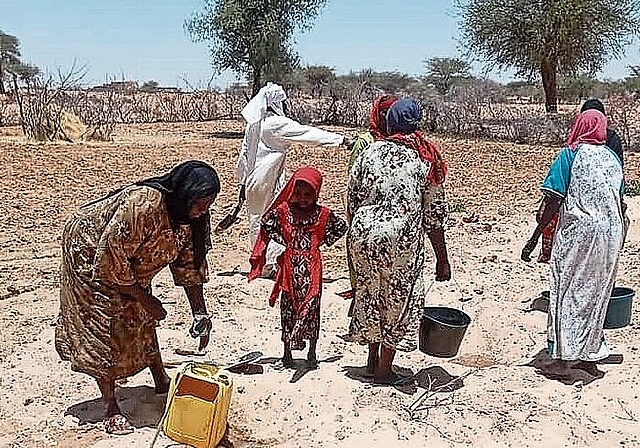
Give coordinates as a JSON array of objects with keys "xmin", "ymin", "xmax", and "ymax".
[{"xmin": 262, "ymin": 203, "xmax": 347, "ymax": 350}]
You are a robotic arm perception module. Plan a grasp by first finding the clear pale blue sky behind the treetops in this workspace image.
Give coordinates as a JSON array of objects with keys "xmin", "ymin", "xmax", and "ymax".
[{"xmin": 0, "ymin": 0, "xmax": 640, "ymax": 88}]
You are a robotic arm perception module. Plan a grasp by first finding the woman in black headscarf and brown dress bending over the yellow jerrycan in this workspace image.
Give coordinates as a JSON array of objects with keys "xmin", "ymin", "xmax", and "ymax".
[{"xmin": 55, "ymin": 161, "xmax": 225, "ymax": 434}]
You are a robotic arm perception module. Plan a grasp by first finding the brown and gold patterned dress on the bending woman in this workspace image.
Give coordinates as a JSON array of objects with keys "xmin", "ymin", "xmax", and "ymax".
[{"xmin": 55, "ymin": 186, "xmax": 208, "ymax": 380}]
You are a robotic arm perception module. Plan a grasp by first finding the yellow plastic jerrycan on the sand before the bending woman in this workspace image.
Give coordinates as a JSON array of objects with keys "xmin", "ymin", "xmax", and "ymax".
[{"xmin": 162, "ymin": 361, "xmax": 233, "ymax": 448}]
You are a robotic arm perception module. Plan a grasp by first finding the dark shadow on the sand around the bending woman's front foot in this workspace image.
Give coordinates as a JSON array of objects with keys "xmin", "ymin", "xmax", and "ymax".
[{"xmin": 65, "ymin": 386, "xmax": 167, "ymax": 428}]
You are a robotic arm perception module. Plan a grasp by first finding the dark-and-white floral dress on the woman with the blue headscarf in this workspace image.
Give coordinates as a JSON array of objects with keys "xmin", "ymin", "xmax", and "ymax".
[{"xmin": 344, "ymin": 141, "xmax": 447, "ymax": 351}]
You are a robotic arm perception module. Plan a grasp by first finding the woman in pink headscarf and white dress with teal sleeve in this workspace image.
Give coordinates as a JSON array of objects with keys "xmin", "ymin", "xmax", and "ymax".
[{"xmin": 522, "ymin": 109, "xmax": 623, "ymax": 377}]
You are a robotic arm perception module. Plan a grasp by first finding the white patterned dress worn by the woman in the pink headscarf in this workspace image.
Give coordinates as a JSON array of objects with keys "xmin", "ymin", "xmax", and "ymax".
[{"xmin": 543, "ymin": 144, "xmax": 623, "ymax": 361}]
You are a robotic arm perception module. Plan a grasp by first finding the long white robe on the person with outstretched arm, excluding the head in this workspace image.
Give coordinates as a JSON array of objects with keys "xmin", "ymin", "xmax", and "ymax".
[{"xmin": 237, "ymin": 114, "xmax": 344, "ymax": 265}]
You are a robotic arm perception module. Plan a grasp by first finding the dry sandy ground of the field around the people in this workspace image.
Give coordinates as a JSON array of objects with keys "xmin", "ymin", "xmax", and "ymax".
[{"xmin": 0, "ymin": 122, "xmax": 640, "ymax": 447}]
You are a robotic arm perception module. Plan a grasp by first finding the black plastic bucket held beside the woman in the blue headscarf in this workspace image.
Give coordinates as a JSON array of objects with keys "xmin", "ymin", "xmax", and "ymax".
[{"xmin": 419, "ymin": 306, "xmax": 471, "ymax": 358}]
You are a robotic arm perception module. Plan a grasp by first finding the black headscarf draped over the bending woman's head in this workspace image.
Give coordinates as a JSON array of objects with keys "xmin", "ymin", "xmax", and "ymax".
[{"xmin": 136, "ymin": 160, "xmax": 220, "ymax": 269}]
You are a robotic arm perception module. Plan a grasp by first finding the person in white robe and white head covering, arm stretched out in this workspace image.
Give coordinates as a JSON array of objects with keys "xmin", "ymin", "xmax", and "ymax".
[{"xmin": 237, "ymin": 83, "xmax": 347, "ymax": 276}]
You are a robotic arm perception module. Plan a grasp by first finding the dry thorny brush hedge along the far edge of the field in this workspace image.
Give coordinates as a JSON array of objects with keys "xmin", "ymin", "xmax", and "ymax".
[{"xmin": 0, "ymin": 75, "xmax": 640, "ymax": 150}]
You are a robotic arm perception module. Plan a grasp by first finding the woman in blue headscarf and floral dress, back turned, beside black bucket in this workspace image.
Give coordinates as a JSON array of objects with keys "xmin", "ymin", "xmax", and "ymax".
[{"xmin": 344, "ymin": 99, "xmax": 451, "ymax": 384}]
